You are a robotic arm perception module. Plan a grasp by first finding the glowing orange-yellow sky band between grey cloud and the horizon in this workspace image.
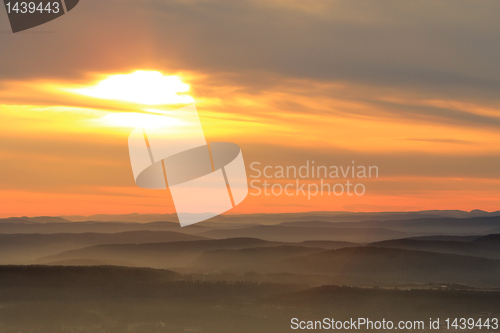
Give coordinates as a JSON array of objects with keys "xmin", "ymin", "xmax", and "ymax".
[{"xmin": 0, "ymin": 69, "xmax": 500, "ymax": 216}]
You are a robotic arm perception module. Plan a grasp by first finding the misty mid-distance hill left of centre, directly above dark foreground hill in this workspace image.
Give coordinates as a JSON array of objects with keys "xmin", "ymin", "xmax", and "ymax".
[{"xmin": 36, "ymin": 238, "xmax": 279, "ymax": 268}]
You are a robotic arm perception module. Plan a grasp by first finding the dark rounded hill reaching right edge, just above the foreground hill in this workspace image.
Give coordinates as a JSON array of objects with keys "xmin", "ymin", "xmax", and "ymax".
[{"xmin": 272, "ymin": 247, "xmax": 500, "ymax": 287}]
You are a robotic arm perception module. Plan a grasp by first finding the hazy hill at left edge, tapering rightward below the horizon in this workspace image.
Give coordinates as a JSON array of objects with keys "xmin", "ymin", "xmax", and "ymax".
[{"xmin": 0, "ymin": 231, "xmax": 206, "ymax": 264}]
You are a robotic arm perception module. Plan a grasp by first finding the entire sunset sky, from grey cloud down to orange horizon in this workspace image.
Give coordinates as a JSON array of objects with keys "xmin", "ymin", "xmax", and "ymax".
[{"xmin": 0, "ymin": 0, "xmax": 500, "ymax": 217}]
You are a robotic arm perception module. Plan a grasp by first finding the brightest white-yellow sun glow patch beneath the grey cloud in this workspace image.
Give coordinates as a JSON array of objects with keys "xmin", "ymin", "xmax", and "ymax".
[{"xmin": 71, "ymin": 71, "xmax": 194, "ymax": 105}]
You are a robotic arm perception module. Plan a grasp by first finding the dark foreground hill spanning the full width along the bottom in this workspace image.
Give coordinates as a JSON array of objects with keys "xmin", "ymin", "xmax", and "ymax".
[{"xmin": 0, "ymin": 266, "xmax": 500, "ymax": 333}]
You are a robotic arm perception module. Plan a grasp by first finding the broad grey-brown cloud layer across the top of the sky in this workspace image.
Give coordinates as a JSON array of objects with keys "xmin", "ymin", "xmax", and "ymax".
[{"xmin": 0, "ymin": 0, "xmax": 500, "ymax": 99}]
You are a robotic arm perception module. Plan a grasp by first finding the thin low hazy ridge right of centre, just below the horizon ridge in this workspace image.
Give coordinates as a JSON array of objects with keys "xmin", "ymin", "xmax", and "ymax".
[{"xmin": 199, "ymin": 225, "xmax": 408, "ymax": 243}]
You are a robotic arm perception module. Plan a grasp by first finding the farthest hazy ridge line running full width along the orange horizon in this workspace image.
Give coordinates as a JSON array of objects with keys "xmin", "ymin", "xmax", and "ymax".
[{"xmin": 0, "ymin": 212, "xmax": 500, "ymax": 243}]
